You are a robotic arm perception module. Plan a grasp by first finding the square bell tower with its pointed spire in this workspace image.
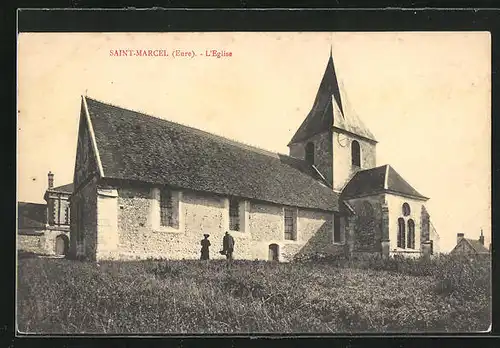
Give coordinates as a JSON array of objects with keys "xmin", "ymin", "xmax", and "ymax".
[{"xmin": 288, "ymin": 50, "xmax": 377, "ymax": 191}]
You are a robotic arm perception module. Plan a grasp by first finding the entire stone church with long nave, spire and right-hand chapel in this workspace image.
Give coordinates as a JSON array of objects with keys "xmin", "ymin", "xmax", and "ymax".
[{"xmin": 70, "ymin": 54, "xmax": 433, "ymax": 261}]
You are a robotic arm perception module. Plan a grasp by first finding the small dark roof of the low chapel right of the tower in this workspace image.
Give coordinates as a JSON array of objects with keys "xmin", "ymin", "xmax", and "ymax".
[{"xmin": 342, "ymin": 164, "xmax": 428, "ymax": 200}]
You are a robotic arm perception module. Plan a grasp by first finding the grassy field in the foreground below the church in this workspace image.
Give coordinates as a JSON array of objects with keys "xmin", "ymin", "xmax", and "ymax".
[{"xmin": 17, "ymin": 257, "xmax": 491, "ymax": 334}]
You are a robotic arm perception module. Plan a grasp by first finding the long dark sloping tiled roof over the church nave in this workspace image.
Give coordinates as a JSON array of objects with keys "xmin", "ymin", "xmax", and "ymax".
[{"xmin": 83, "ymin": 97, "xmax": 339, "ymax": 211}]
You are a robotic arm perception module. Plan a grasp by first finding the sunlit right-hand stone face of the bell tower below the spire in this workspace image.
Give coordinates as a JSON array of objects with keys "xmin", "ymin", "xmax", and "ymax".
[{"xmin": 332, "ymin": 132, "xmax": 377, "ymax": 191}]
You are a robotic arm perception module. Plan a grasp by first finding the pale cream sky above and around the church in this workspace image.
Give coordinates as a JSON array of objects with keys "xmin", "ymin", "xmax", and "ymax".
[{"xmin": 17, "ymin": 32, "xmax": 491, "ymax": 251}]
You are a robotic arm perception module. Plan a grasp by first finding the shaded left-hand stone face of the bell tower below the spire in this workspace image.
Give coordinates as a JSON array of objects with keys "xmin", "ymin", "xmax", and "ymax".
[{"xmin": 290, "ymin": 132, "xmax": 333, "ymax": 185}]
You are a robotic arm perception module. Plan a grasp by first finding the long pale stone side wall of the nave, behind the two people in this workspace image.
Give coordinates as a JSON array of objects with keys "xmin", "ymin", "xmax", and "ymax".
[{"xmin": 97, "ymin": 185, "xmax": 345, "ymax": 261}]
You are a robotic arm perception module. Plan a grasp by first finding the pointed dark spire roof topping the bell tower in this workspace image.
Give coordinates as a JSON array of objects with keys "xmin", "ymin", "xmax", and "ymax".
[{"xmin": 288, "ymin": 54, "xmax": 376, "ymax": 145}]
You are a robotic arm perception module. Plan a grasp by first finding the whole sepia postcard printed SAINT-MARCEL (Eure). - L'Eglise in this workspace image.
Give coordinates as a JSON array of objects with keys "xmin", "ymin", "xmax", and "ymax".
[{"xmin": 16, "ymin": 32, "xmax": 491, "ymax": 335}]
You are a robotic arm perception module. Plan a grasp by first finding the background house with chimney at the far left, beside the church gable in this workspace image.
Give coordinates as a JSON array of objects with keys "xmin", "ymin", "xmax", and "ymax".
[{"xmin": 17, "ymin": 172, "xmax": 73, "ymax": 255}]
